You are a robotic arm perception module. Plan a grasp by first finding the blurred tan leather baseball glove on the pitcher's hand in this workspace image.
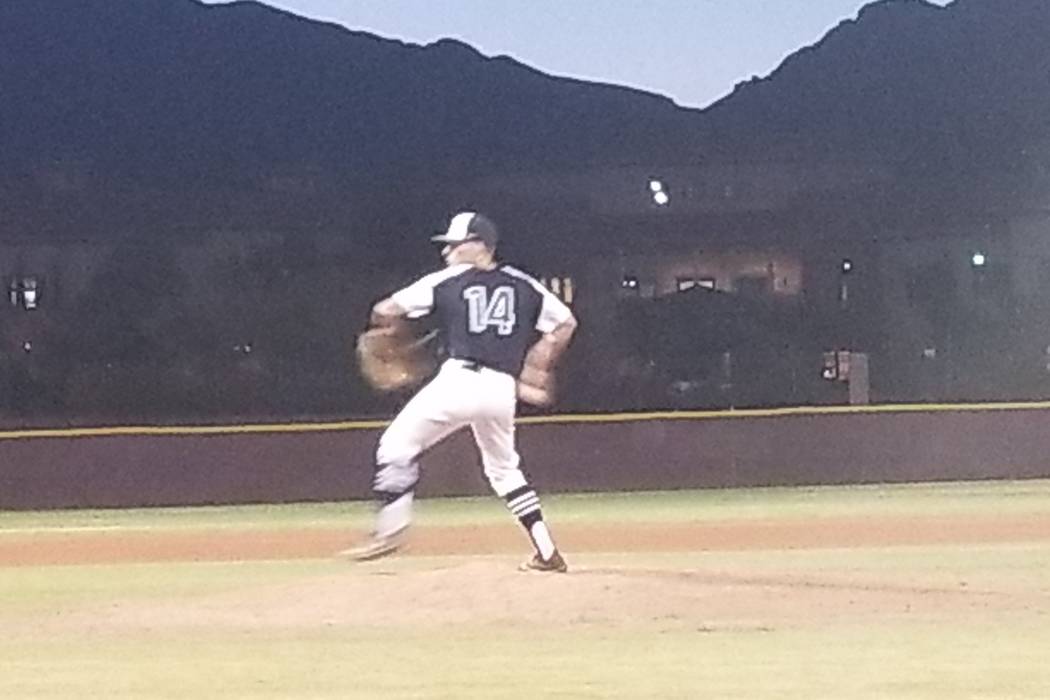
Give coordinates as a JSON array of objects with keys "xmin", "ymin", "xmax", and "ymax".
[{"xmin": 356, "ymin": 326, "xmax": 435, "ymax": 391}]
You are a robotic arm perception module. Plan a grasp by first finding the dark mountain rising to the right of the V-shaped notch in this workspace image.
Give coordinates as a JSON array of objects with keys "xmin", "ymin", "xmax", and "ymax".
[{"xmin": 705, "ymin": 0, "xmax": 1050, "ymax": 172}]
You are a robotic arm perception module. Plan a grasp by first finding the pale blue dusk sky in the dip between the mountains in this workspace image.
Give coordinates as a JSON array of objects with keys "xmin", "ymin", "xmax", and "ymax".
[{"xmin": 197, "ymin": 0, "xmax": 949, "ymax": 107}]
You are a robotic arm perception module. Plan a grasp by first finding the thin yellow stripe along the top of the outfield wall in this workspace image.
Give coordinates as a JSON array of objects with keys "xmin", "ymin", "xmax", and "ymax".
[{"xmin": 6, "ymin": 401, "xmax": 1050, "ymax": 440}]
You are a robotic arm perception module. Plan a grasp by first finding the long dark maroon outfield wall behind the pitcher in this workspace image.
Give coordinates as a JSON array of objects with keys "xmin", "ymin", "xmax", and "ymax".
[{"xmin": 0, "ymin": 403, "xmax": 1050, "ymax": 509}]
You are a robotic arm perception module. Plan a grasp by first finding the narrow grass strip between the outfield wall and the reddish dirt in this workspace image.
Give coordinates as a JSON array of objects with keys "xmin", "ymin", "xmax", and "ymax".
[{"xmin": 0, "ymin": 480, "xmax": 1050, "ymax": 536}]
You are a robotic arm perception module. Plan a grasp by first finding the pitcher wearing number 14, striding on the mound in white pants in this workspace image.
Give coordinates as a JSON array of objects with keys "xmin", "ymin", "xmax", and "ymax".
[{"xmin": 345, "ymin": 212, "xmax": 576, "ymax": 572}]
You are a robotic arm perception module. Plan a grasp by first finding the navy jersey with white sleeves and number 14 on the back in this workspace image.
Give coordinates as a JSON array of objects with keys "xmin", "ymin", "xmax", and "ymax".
[{"xmin": 392, "ymin": 264, "xmax": 572, "ymax": 377}]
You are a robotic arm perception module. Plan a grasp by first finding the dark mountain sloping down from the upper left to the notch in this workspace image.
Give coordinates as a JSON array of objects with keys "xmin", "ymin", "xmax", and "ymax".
[{"xmin": 0, "ymin": 0, "xmax": 701, "ymax": 193}]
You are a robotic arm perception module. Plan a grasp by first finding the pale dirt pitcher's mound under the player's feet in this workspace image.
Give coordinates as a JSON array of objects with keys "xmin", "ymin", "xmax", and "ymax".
[{"xmin": 47, "ymin": 556, "xmax": 1033, "ymax": 633}]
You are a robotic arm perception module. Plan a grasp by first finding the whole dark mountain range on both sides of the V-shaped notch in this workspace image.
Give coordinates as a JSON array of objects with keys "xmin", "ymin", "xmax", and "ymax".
[{"xmin": 0, "ymin": 0, "xmax": 1050, "ymax": 235}]
